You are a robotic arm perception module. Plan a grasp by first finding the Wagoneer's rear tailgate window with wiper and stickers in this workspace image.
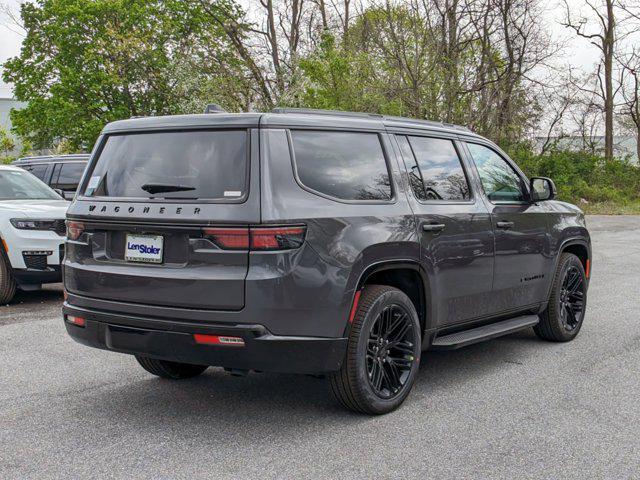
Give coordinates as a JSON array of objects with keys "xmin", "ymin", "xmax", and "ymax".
[{"xmin": 84, "ymin": 130, "xmax": 247, "ymax": 200}]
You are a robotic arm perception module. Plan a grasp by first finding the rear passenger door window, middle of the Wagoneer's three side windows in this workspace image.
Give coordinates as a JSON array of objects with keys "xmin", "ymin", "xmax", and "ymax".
[{"xmin": 403, "ymin": 137, "xmax": 469, "ymax": 200}]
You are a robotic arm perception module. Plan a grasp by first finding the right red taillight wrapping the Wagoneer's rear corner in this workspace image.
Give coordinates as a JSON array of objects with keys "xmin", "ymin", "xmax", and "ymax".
[{"xmin": 202, "ymin": 225, "xmax": 306, "ymax": 251}]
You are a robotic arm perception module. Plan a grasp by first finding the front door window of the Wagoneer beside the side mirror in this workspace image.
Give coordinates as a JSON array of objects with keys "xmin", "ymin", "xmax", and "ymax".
[{"xmin": 467, "ymin": 143, "xmax": 525, "ymax": 202}]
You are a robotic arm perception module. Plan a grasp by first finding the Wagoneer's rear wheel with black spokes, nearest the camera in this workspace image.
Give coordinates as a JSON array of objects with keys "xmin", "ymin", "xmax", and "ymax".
[{"xmin": 330, "ymin": 285, "xmax": 421, "ymax": 415}]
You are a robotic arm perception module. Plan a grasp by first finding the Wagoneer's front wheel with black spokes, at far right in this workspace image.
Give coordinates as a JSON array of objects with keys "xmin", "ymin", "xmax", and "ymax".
[{"xmin": 533, "ymin": 253, "xmax": 587, "ymax": 342}]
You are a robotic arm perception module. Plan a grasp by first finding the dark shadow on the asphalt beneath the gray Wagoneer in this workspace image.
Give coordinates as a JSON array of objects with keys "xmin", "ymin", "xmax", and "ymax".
[{"xmin": 74, "ymin": 332, "xmax": 540, "ymax": 428}]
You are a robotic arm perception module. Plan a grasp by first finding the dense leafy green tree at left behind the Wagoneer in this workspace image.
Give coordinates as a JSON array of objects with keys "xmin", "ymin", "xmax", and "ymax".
[{"xmin": 3, "ymin": 0, "xmax": 242, "ymax": 150}]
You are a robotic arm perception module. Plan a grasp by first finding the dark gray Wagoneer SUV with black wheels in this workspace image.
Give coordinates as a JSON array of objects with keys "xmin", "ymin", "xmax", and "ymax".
[{"xmin": 63, "ymin": 109, "xmax": 591, "ymax": 414}]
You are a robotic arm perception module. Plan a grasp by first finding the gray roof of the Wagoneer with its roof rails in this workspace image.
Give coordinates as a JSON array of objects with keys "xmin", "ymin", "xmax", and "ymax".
[{"xmin": 102, "ymin": 108, "xmax": 477, "ymax": 137}]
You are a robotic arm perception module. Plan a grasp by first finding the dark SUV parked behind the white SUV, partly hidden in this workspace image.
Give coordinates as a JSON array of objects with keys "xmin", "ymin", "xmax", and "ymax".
[{"xmin": 12, "ymin": 154, "xmax": 89, "ymax": 200}]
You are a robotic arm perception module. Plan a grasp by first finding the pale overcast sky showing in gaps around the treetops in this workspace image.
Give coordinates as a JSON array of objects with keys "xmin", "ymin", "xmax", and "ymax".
[{"xmin": 0, "ymin": 0, "xmax": 616, "ymax": 97}]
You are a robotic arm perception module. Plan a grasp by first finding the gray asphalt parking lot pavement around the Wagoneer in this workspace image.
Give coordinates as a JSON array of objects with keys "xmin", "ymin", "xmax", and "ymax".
[{"xmin": 0, "ymin": 217, "xmax": 640, "ymax": 480}]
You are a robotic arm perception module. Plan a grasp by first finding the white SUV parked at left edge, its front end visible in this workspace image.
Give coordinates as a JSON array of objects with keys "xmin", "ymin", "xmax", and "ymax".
[{"xmin": 0, "ymin": 165, "xmax": 69, "ymax": 303}]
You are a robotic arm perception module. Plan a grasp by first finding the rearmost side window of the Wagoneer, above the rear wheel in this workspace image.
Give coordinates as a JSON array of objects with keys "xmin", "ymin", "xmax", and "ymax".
[{"xmin": 291, "ymin": 131, "xmax": 391, "ymax": 200}]
